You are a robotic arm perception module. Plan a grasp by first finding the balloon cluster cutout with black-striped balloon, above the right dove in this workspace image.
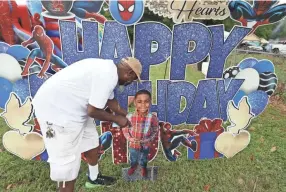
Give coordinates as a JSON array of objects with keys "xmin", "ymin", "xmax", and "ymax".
[{"xmin": 223, "ymin": 58, "xmax": 278, "ymax": 116}]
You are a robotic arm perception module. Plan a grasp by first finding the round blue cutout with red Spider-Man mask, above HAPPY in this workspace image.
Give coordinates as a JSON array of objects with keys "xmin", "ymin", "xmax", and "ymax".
[{"xmin": 109, "ymin": 0, "xmax": 144, "ymax": 26}]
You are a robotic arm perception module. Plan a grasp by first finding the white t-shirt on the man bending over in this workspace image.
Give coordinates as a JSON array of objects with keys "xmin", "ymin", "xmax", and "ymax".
[{"xmin": 32, "ymin": 58, "xmax": 118, "ymax": 126}]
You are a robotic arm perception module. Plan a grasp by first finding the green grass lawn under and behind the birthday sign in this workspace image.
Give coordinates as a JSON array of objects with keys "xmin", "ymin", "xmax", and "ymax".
[{"xmin": 0, "ymin": 53, "xmax": 286, "ymax": 192}]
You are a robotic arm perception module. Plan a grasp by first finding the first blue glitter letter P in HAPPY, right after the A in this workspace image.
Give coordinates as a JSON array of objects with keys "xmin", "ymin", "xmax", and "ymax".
[{"xmin": 134, "ymin": 22, "xmax": 172, "ymax": 80}]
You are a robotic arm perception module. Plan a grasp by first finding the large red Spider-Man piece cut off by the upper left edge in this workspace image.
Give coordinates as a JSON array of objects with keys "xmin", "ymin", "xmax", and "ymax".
[{"xmin": 0, "ymin": 0, "xmax": 17, "ymax": 45}]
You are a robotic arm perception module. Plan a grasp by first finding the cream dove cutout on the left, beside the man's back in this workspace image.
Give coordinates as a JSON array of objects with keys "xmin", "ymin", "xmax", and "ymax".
[{"xmin": 0, "ymin": 92, "xmax": 34, "ymax": 134}]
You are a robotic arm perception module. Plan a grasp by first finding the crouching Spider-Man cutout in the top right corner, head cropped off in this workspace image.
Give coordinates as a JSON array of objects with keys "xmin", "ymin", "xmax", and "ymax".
[{"xmin": 228, "ymin": 0, "xmax": 286, "ymax": 32}]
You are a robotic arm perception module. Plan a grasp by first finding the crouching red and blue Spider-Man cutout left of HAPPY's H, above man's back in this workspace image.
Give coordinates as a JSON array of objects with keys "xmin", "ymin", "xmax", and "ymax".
[{"xmin": 22, "ymin": 25, "xmax": 68, "ymax": 78}]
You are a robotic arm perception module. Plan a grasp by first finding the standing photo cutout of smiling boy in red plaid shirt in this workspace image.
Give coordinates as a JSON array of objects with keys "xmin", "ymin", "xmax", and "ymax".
[{"xmin": 122, "ymin": 90, "xmax": 159, "ymax": 178}]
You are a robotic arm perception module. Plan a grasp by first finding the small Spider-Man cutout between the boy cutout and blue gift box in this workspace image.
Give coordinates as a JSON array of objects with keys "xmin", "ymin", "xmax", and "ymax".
[{"xmin": 159, "ymin": 122, "xmax": 197, "ymax": 161}]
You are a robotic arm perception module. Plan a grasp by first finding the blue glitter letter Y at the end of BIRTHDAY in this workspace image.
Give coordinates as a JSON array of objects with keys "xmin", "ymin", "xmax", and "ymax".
[{"xmin": 217, "ymin": 79, "xmax": 244, "ymax": 121}]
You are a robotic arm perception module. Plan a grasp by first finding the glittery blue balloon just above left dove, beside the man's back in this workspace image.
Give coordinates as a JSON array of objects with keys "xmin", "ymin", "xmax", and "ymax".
[{"xmin": 12, "ymin": 78, "xmax": 30, "ymax": 103}]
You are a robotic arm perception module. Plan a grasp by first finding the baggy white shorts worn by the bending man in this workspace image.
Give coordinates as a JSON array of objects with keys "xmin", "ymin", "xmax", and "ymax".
[{"xmin": 38, "ymin": 118, "xmax": 99, "ymax": 182}]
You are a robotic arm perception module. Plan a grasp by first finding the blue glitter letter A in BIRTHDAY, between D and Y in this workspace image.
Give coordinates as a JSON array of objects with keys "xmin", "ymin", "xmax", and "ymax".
[{"xmin": 188, "ymin": 79, "xmax": 220, "ymax": 124}]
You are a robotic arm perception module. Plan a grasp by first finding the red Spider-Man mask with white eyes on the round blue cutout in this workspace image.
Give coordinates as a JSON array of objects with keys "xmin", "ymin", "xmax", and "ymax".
[{"xmin": 118, "ymin": 0, "xmax": 135, "ymax": 21}]
